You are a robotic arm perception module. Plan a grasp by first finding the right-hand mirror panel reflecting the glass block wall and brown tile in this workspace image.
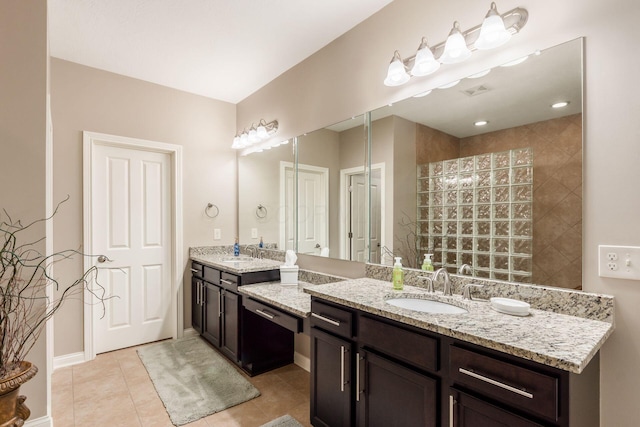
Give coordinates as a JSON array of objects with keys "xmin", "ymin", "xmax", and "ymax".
[{"xmin": 370, "ymin": 39, "xmax": 583, "ymax": 289}]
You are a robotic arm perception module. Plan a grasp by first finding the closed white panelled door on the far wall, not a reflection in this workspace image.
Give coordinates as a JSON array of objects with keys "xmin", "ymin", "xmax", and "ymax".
[{"xmin": 91, "ymin": 145, "xmax": 172, "ymax": 353}]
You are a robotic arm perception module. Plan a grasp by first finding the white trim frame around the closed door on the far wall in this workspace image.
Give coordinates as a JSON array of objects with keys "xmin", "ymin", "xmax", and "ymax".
[{"xmin": 82, "ymin": 131, "xmax": 184, "ymax": 361}]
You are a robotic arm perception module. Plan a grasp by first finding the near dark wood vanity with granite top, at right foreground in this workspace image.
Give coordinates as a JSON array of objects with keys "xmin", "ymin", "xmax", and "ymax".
[{"xmin": 307, "ymin": 279, "xmax": 613, "ymax": 427}]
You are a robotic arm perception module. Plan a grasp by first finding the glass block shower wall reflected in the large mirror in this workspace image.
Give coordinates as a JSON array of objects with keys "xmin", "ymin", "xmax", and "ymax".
[{"xmin": 417, "ymin": 148, "xmax": 533, "ymax": 283}]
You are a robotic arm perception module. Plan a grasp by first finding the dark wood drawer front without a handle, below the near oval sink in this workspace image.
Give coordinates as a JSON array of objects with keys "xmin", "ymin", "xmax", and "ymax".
[{"xmin": 358, "ymin": 316, "xmax": 440, "ymax": 371}]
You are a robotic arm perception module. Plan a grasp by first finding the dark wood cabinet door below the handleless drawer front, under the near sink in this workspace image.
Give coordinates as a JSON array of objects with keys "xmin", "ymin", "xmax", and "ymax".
[{"xmin": 356, "ymin": 349, "xmax": 439, "ymax": 427}]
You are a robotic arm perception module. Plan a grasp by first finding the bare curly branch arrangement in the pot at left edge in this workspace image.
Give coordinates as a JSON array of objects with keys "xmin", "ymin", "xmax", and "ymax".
[{"xmin": 0, "ymin": 197, "xmax": 107, "ymax": 378}]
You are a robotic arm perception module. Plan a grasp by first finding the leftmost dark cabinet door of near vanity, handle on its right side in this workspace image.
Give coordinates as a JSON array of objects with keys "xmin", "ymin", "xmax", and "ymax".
[{"xmin": 311, "ymin": 328, "xmax": 353, "ymax": 427}]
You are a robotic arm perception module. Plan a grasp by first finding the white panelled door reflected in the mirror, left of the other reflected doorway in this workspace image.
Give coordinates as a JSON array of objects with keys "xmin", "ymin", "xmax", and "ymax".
[{"xmin": 298, "ymin": 164, "xmax": 329, "ymax": 256}]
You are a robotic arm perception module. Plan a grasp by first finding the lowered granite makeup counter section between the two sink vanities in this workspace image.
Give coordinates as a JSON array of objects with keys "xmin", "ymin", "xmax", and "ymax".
[{"xmin": 238, "ymin": 281, "xmax": 318, "ymax": 317}]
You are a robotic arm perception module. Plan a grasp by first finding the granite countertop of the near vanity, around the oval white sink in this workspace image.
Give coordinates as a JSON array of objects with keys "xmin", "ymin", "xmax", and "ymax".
[{"xmin": 304, "ymin": 278, "xmax": 613, "ymax": 373}]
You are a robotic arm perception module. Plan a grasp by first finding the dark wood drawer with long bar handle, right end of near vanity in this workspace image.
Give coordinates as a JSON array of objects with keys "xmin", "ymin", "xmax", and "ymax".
[{"xmin": 449, "ymin": 346, "xmax": 559, "ymax": 421}]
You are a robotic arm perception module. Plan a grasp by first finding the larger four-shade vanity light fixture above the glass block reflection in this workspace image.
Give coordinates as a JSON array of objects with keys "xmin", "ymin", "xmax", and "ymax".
[{"xmin": 384, "ymin": 2, "xmax": 529, "ymax": 86}]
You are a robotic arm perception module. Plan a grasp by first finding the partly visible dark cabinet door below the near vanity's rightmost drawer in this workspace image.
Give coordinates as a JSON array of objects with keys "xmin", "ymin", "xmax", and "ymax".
[{"xmin": 449, "ymin": 389, "xmax": 542, "ymax": 427}]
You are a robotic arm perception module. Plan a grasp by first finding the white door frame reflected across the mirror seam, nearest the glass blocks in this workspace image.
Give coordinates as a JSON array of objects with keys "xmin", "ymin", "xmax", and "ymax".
[{"xmin": 338, "ymin": 163, "xmax": 386, "ymax": 262}]
